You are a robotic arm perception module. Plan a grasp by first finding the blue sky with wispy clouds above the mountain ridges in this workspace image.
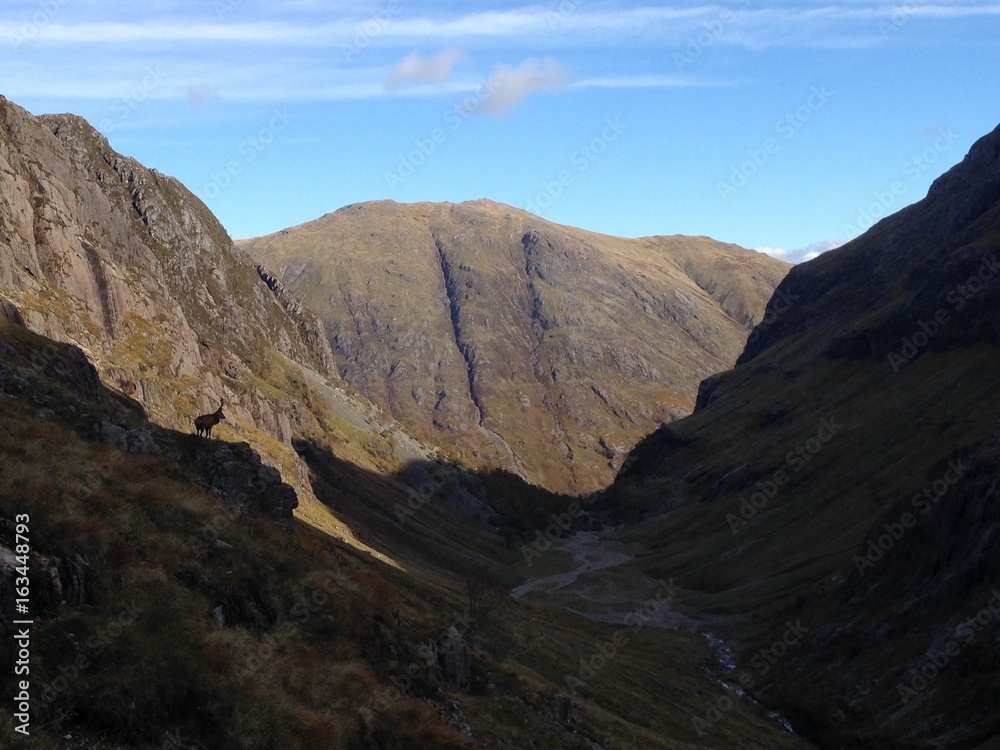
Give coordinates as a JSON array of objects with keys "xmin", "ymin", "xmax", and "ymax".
[{"xmin": 0, "ymin": 0, "xmax": 1000, "ymax": 260}]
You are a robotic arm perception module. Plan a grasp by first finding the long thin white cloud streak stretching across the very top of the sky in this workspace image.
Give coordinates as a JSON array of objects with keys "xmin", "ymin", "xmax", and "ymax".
[{"xmin": 7, "ymin": 2, "xmax": 1000, "ymax": 47}]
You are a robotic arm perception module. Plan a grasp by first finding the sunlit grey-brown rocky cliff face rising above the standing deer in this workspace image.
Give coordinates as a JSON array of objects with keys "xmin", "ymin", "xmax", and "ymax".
[{"xmin": 0, "ymin": 99, "xmax": 332, "ymax": 440}]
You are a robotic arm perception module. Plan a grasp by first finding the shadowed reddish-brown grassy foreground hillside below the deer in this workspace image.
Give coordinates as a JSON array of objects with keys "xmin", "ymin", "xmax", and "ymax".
[{"xmin": 0, "ymin": 288, "xmax": 803, "ymax": 750}]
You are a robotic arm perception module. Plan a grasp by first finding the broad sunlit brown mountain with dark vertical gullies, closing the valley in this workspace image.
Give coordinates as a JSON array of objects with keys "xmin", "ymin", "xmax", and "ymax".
[{"xmin": 239, "ymin": 201, "xmax": 788, "ymax": 491}]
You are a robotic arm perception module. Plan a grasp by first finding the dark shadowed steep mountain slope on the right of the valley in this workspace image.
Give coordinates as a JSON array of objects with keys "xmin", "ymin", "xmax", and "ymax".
[{"xmin": 606, "ymin": 122, "xmax": 1000, "ymax": 748}]
